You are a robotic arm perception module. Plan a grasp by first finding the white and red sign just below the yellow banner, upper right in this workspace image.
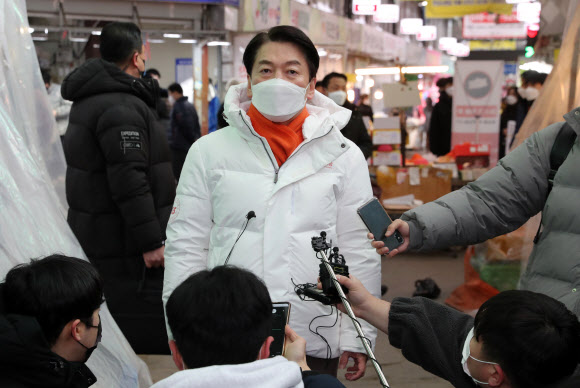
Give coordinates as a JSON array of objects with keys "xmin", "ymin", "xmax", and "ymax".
[{"xmin": 463, "ymin": 11, "xmax": 526, "ymax": 39}]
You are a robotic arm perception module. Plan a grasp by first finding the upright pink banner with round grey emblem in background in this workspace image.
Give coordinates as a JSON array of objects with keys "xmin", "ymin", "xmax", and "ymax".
[{"xmin": 452, "ymin": 61, "xmax": 504, "ymax": 165}]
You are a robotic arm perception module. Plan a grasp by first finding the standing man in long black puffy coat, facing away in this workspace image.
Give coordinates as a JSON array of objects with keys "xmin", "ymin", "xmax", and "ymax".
[{"xmin": 61, "ymin": 23, "xmax": 175, "ymax": 353}]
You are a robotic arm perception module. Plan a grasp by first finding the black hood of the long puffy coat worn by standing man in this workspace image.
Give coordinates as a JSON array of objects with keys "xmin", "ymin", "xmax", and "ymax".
[{"xmin": 61, "ymin": 58, "xmax": 159, "ymax": 107}]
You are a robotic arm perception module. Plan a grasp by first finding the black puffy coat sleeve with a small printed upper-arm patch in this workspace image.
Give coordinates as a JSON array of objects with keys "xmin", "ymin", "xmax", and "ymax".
[{"xmin": 96, "ymin": 105, "xmax": 164, "ymax": 252}]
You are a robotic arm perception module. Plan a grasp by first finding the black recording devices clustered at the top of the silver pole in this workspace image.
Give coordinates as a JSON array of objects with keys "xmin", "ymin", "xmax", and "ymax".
[{"xmin": 296, "ymin": 232, "xmax": 348, "ymax": 305}]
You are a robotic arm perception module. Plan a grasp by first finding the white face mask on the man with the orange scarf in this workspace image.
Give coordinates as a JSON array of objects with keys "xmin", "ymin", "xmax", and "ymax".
[{"xmin": 252, "ymin": 78, "xmax": 310, "ymax": 123}]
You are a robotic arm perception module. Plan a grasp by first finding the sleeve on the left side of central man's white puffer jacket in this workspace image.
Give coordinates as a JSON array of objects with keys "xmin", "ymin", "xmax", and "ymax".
[{"xmin": 163, "ymin": 142, "xmax": 213, "ymax": 339}]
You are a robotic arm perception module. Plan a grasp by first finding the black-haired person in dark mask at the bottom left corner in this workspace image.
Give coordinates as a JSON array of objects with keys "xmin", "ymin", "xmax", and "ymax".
[{"xmin": 0, "ymin": 255, "xmax": 104, "ymax": 388}]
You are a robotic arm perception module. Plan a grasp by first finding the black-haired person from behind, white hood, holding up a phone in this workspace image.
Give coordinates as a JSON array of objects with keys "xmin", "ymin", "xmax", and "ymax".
[{"xmin": 153, "ymin": 266, "xmax": 344, "ymax": 388}]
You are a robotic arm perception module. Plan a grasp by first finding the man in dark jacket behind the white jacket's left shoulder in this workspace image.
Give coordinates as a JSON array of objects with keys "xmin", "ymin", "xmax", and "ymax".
[{"xmin": 167, "ymin": 82, "xmax": 201, "ymax": 182}]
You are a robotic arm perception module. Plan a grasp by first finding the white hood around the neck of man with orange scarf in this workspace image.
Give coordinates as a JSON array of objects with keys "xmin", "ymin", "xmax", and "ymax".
[{"xmin": 224, "ymin": 82, "xmax": 352, "ymax": 139}]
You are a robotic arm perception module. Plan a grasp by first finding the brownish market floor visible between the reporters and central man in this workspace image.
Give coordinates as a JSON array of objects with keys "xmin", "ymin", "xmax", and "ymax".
[{"xmin": 141, "ymin": 247, "xmax": 463, "ymax": 388}]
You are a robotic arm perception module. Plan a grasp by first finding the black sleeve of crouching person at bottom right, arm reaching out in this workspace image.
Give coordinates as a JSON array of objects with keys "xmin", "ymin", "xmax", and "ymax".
[{"xmin": 389, "ymin": 297, "xmax": 475, "ymax": 388}]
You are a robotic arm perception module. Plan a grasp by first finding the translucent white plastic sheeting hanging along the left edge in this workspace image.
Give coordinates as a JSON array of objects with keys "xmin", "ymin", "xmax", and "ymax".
[{"xmin": 0, "ymin": 0, "xmax": 152, "ymax": 388}]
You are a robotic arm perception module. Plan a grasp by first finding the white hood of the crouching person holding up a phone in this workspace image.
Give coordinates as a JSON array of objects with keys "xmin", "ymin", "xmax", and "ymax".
[{"xmin": 151, "ymin": 356, "xmax": 304, "ymax": 388}]
